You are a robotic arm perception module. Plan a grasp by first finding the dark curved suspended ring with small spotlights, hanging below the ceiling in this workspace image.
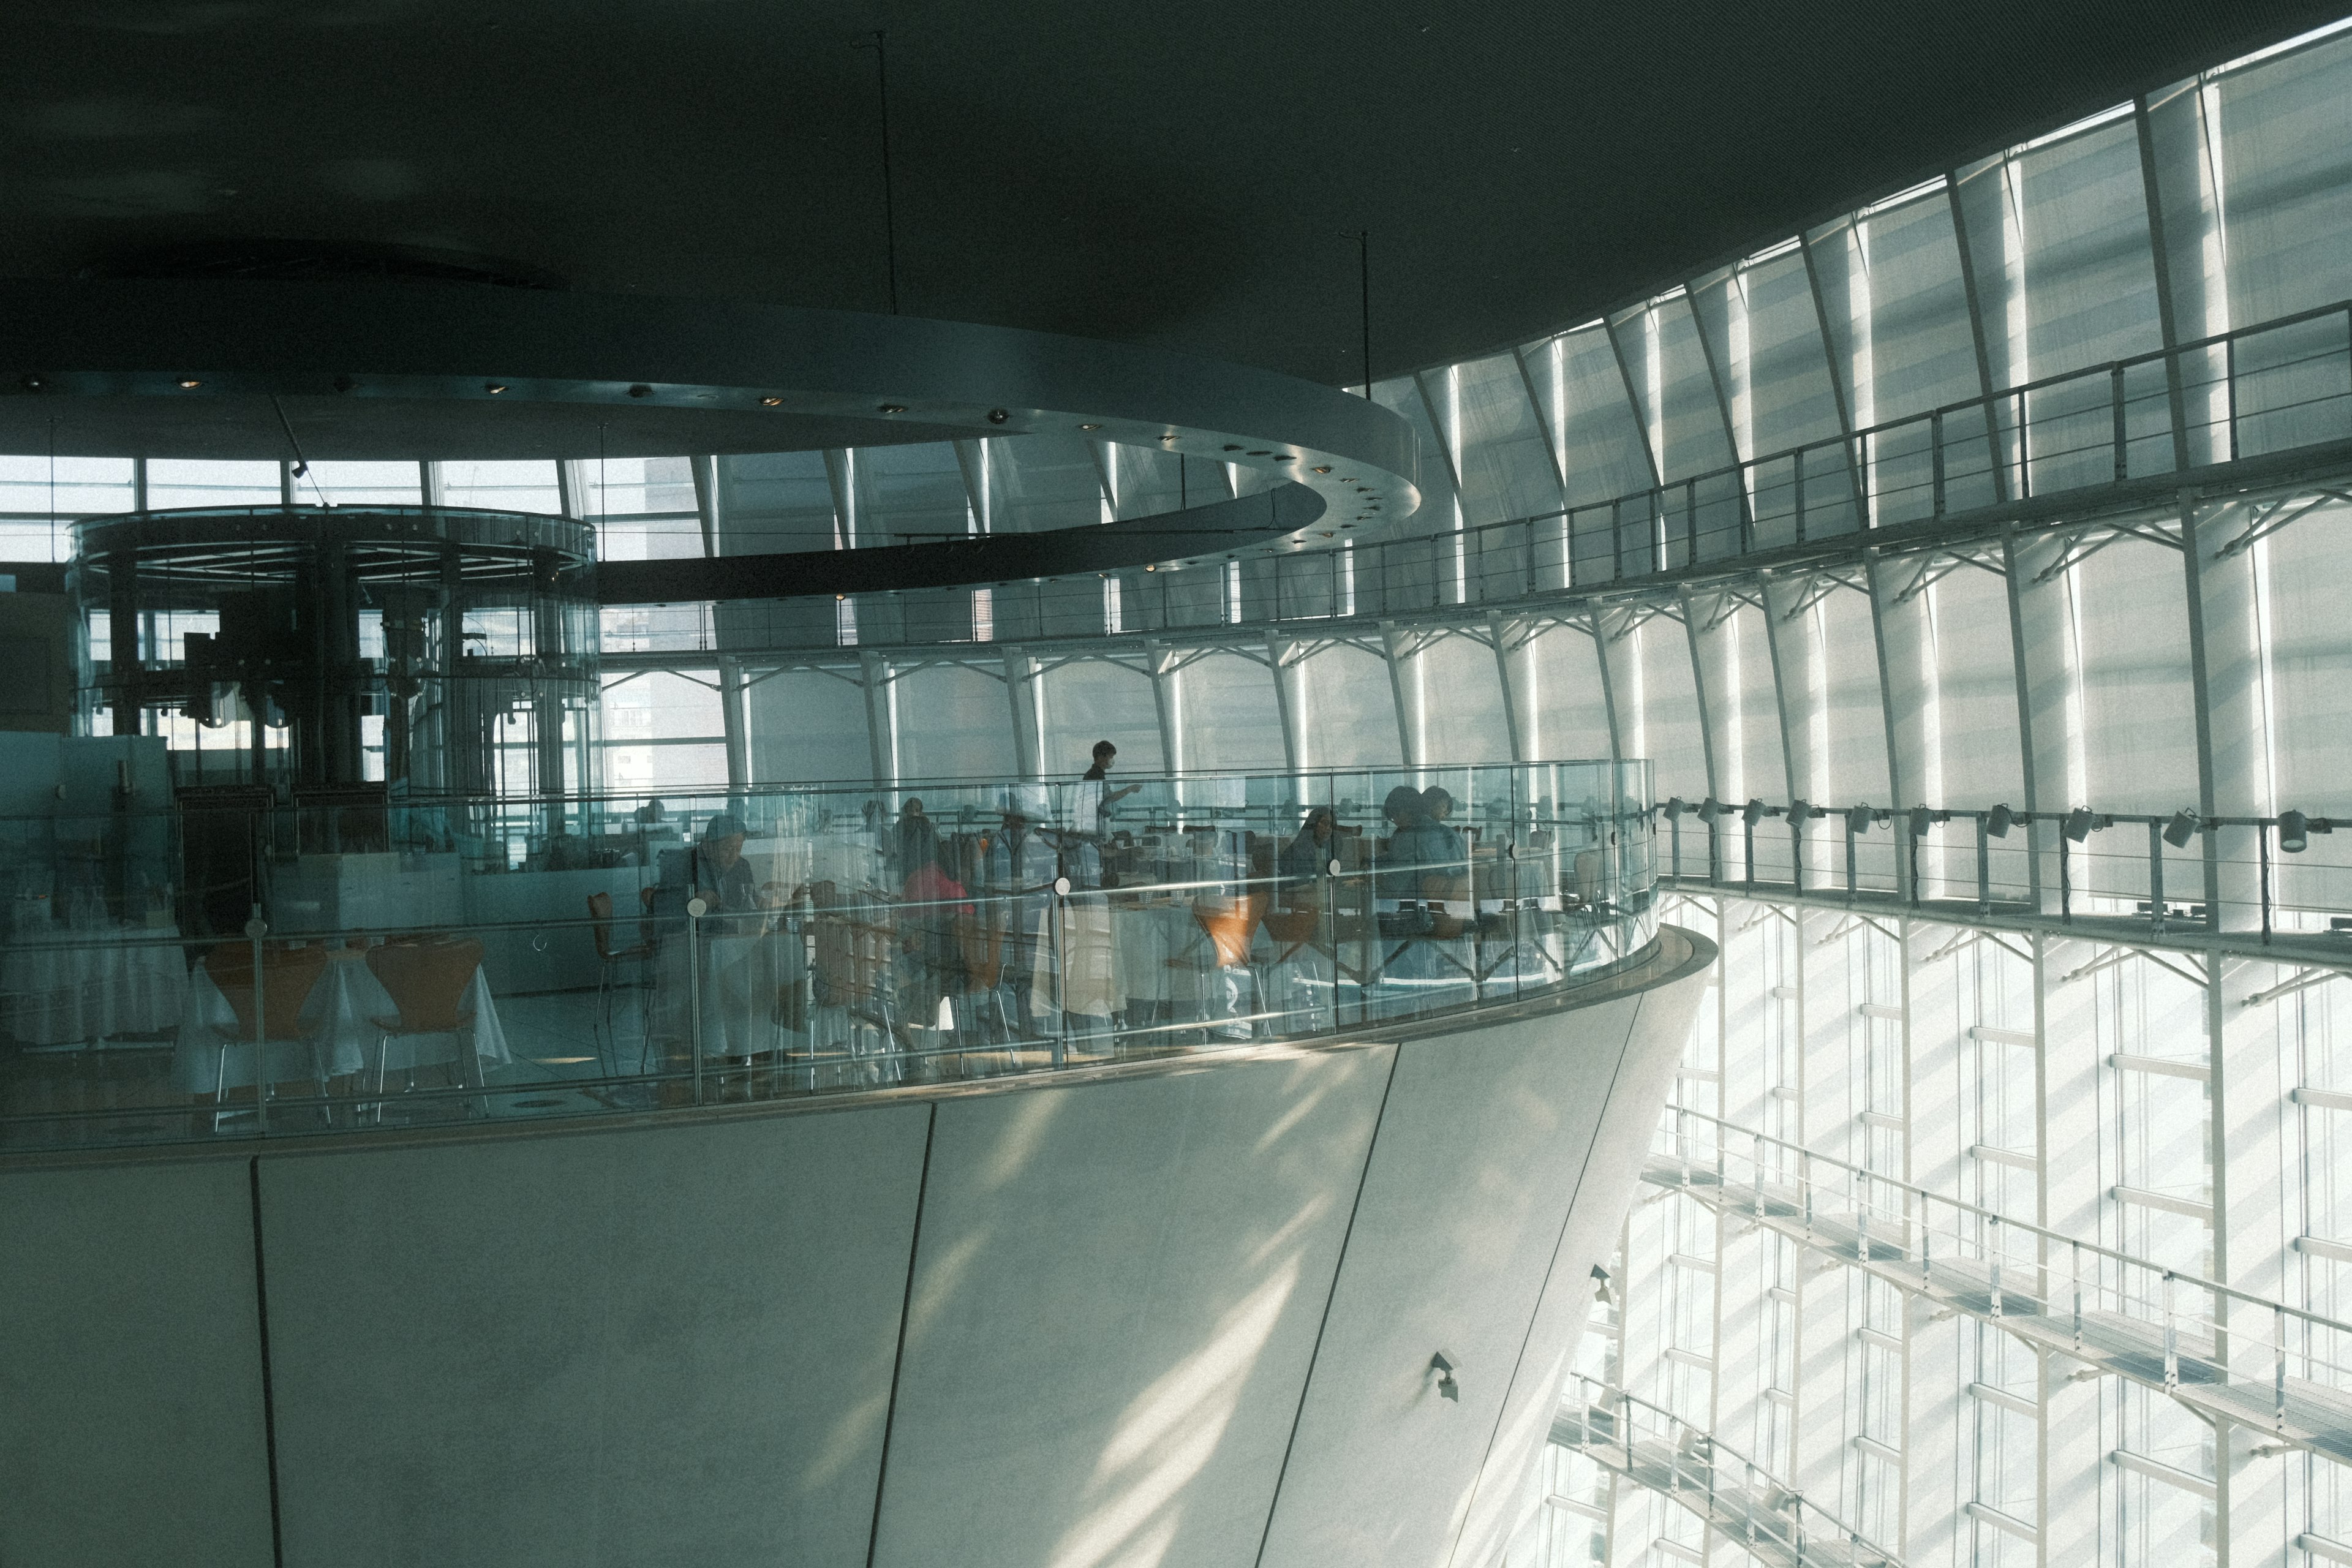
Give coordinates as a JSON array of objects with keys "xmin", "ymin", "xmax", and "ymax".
[{"xmin": 0, "ymin": 280, "xmax": 1420, "ymax": 569}]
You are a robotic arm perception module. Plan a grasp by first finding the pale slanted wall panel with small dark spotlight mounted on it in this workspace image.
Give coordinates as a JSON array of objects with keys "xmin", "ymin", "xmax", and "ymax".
[{"xmin": 1263, "ymin": 997, "xmax": 1656, "ymax": 1568}]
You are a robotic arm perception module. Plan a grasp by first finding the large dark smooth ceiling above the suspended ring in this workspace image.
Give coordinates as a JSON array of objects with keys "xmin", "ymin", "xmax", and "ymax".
[{"xmin": 0, "ymin": 0, "xmax": 2338, "ymax": 383}]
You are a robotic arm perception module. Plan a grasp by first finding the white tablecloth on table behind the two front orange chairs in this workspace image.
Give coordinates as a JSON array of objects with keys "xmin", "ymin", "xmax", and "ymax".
[{"xmin": 172, "ymin": 948, "xmax": 513, "ymax": 1093}]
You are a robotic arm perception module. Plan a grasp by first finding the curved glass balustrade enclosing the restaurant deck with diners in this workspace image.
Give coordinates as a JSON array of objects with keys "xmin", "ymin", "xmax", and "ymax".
[{"xmin": 0, "ymin": 762, "xmax": 1658, "ymax": 1150}]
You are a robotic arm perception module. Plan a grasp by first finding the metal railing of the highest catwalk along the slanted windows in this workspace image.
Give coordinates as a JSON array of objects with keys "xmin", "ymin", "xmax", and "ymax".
[{"xmin": 647, "ymin": 301, "xmax": 2352, "ymax": 654}]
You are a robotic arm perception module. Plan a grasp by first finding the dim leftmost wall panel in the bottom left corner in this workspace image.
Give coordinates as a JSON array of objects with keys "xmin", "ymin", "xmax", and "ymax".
[{"xmin": 0, "ymin": 1159, "xmax": 271, "ymax": 1568}]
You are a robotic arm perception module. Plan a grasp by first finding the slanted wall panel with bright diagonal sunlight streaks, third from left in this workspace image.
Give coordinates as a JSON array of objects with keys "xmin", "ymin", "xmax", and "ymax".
[{"xmin": 875, "ymin": 1046, "xmax": 1395, "ymax": 1568}]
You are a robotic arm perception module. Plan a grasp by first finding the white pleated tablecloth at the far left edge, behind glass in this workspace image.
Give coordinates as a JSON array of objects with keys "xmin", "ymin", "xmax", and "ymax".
[{"xmin": 0, "ymin": 926, "xmax": 188, "ymax": 1046}]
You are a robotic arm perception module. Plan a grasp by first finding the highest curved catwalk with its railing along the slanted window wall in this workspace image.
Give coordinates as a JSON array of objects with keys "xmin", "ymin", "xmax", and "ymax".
[{"xmin": 639, "ymin": 301, "xmax": 2352, "ymax": 668}]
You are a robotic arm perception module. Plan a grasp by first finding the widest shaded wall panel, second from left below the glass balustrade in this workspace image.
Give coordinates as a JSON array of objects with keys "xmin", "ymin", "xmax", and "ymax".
[{"xmin": 261, "ymin": 1105, "xmax": 929, "ymax": 1568}]
